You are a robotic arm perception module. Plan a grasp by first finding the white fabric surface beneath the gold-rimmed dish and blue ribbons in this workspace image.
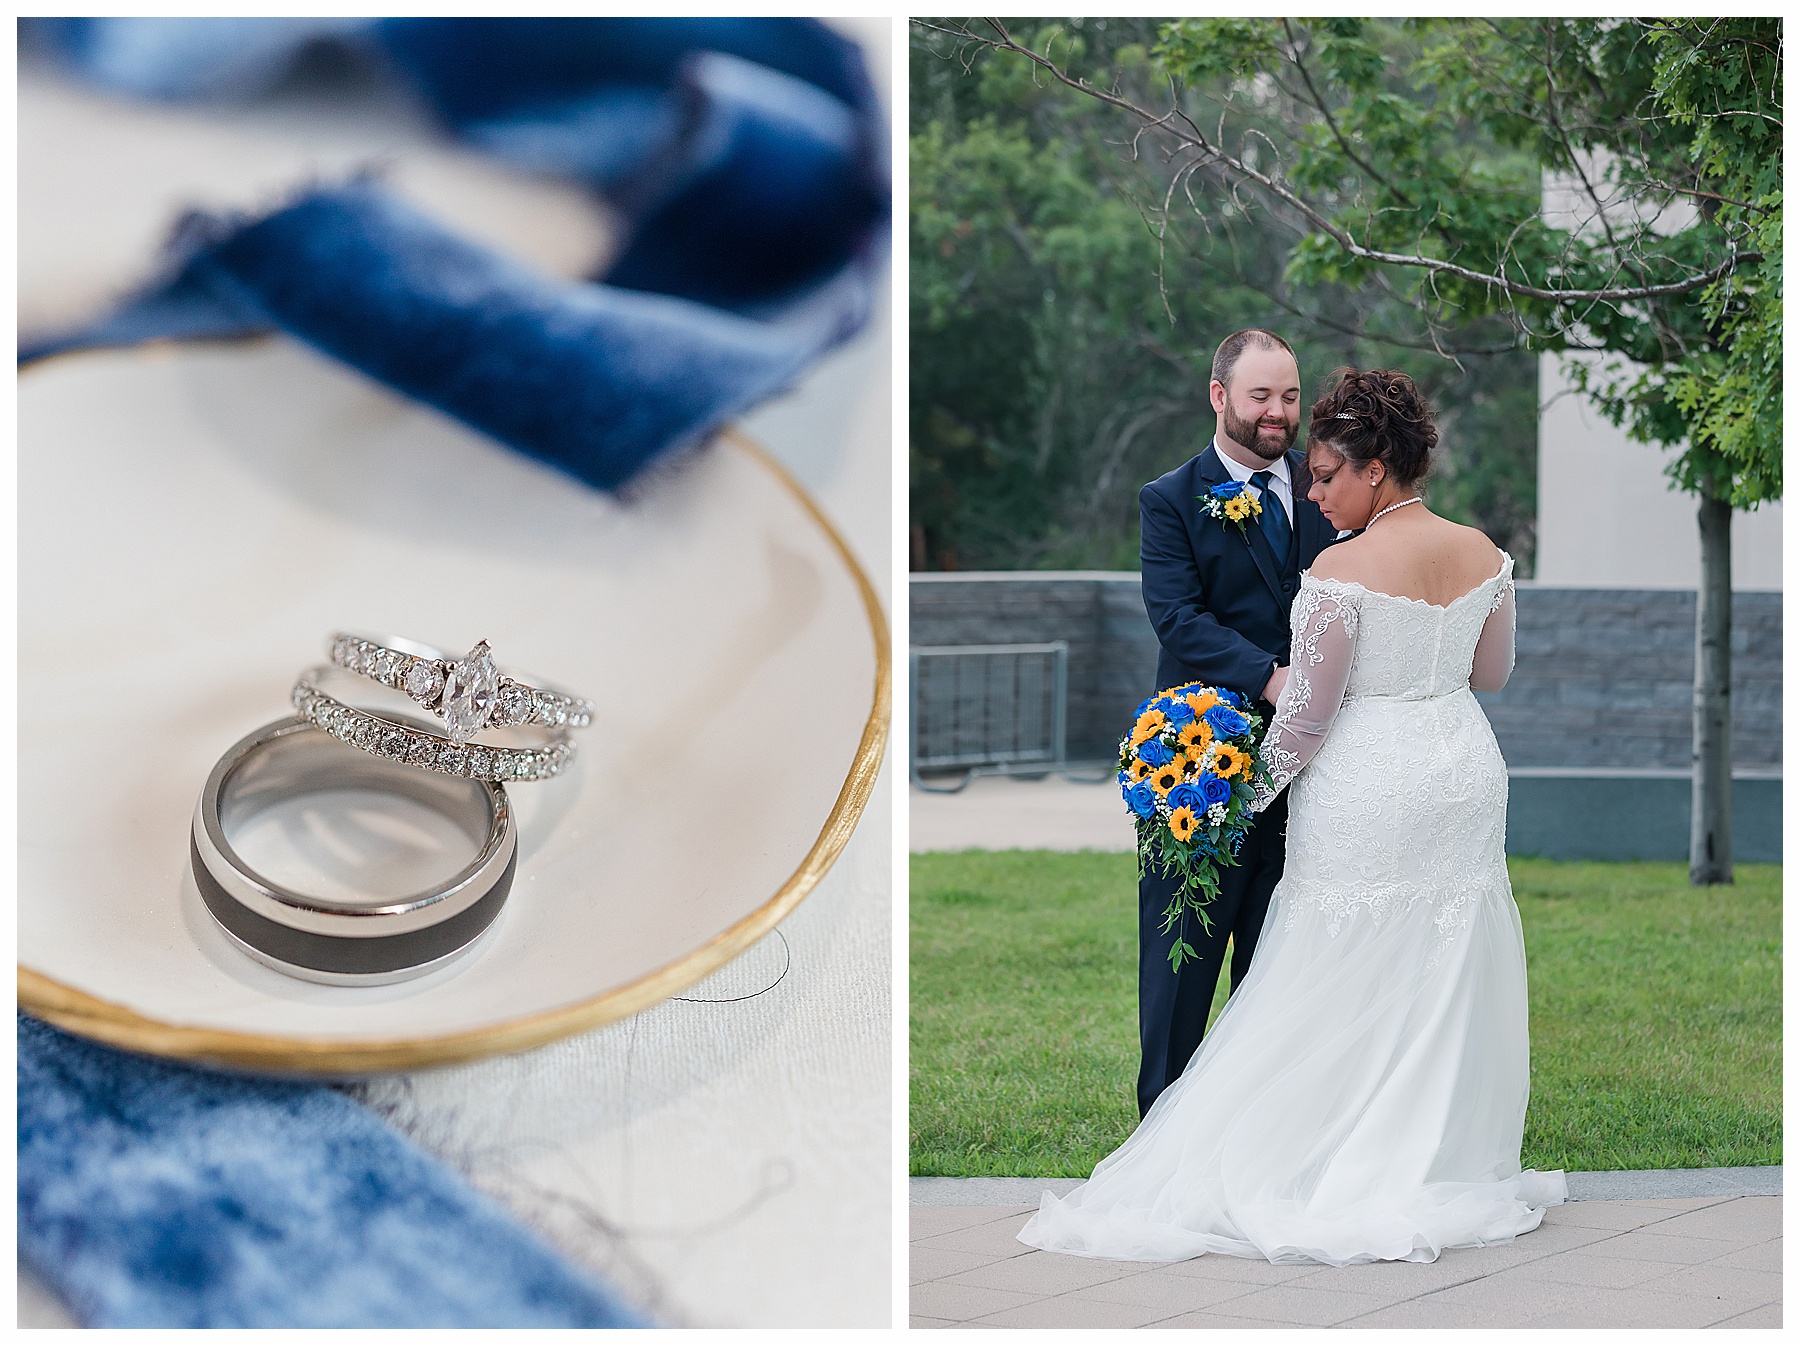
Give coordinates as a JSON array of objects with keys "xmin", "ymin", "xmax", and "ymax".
[{"xmin": 18, "ymin": 22, "xmax": 895, "ymax": 1326}]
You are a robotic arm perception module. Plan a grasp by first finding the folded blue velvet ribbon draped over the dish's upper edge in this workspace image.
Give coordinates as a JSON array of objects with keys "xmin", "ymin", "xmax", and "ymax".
[{"xmin": 20, "ymin": 18, "xmax": 889, "ymax": 489}]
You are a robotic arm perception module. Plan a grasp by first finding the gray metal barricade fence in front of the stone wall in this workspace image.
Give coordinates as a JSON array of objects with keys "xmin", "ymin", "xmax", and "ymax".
[{"xmin": 909, "ymin": 641, "xmax": 1069, "ymax": 794}]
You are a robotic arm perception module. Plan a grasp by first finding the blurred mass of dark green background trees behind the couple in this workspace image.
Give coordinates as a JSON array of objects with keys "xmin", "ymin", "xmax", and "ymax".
[{"xmin": 909, "ymin": 20, "xmax": 1537, "ymax": 574}]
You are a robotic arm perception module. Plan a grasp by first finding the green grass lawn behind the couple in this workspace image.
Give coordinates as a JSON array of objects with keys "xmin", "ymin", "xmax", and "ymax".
[{"xmin": 911, "ymin": 851, "xmax": 1782, "ymax": 1177}]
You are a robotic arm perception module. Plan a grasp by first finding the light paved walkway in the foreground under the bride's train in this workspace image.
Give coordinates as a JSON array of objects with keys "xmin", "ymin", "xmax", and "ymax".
[{"xmin": 911, "ymin": 1168, "xmax": 1782, "ymax": 1328}]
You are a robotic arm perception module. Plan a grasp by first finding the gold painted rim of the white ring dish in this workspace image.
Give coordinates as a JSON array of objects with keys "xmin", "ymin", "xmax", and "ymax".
[{"xmin": 18, "ymin": 362, "xmax": 893, "ymax": 1074}]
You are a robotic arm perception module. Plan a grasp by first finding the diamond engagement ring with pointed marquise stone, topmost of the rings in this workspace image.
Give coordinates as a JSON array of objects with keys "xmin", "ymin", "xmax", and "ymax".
[{"xmin": 331, "ymin": 632, "xmax": 594, "ymax": 743}]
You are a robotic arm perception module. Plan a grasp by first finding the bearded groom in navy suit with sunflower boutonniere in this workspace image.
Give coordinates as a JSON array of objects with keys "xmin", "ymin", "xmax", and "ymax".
[{"xmin": 1138, "ymin": 328, "xmax": 1337, "ymax": 1116}]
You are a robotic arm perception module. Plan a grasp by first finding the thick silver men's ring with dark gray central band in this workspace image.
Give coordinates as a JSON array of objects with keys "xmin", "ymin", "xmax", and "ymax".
[{"xmin": 189, "ymin": 718, "xmax": 517, "ymax": 984}]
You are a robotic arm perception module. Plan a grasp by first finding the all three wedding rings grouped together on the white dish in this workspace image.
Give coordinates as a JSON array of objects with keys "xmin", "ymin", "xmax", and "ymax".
[{"xmin": 191, "ymin": 633, "xmax": 594, "ymax": 986}]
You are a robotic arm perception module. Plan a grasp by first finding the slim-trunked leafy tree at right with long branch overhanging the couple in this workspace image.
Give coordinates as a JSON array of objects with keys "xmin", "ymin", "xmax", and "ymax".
[{"xmin": 945, "ymin": 18, "xmax": 1782, "ymax": 884}]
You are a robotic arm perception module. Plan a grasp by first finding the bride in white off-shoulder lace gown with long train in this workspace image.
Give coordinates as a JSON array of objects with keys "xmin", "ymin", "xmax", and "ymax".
[{"xmin": 1019, "ymin": 369, "xmax": 1566, "ymax": 1267}]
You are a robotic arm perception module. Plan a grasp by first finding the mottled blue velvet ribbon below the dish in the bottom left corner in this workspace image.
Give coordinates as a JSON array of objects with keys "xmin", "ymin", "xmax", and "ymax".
[{"xmin": 18, "ymin": 1015, "xmax": 644, "ymax": 1328}]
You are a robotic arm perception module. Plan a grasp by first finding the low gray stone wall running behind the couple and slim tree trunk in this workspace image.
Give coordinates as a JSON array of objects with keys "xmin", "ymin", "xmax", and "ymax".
[{"xmin": 911, "ymin": 570, "xmax": 1782, "ymax": 772}]
